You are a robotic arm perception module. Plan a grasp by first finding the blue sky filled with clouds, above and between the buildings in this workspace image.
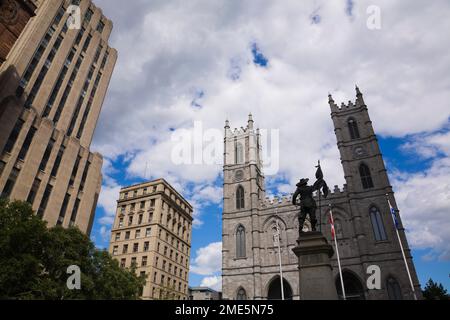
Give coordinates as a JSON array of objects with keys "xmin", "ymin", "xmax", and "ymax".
[{"xmin": 92, "ymin": 0, "xmax": 450, "ymax": 288}]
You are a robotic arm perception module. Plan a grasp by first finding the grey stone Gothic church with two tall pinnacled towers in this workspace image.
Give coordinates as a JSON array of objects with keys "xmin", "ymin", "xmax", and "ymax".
[{"xmin": 222, "ymin": 88, "xmax": 420, "ymax": 299}]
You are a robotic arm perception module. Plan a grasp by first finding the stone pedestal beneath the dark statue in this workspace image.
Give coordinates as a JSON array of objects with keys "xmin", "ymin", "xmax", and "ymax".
[{"xmin": 292, "ymin": 231, "xmax": 338, "ymax": 300}]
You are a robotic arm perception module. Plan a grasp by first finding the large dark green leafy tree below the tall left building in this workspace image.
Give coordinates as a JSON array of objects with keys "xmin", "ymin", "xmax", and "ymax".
[{"xmin": 0, "ymin": 199, "xmax": 145, "ymax": 299}]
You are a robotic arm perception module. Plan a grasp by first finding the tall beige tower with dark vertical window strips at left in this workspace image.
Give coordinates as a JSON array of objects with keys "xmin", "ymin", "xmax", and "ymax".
[{"xmin": 0, "ymin": 0, "xmax": 117, "ymax": 234}]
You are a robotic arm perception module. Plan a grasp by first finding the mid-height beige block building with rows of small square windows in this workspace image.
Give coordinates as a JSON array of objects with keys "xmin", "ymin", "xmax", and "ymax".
[{"xmin": 109, "ymin": 179, "xmax": 192, "ymax": 300}]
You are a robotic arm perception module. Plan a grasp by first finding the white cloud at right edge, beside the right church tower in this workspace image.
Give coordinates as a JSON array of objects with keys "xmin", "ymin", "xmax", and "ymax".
[{"xmin": 393, "ymin": 133, "xmax": 450, "ymax": 260}]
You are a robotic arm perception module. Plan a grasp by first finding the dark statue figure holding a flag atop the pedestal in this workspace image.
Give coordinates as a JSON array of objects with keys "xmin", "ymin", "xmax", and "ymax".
[{"xmin": 292, "ymin": 161, "xmax": 329, "ymax": 239}]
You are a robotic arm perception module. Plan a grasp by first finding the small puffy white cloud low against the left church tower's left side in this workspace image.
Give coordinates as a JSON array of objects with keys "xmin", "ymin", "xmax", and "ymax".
[{"xmin": 191, "ymin": 242, "xmax": 222, "ymax": 276}]
